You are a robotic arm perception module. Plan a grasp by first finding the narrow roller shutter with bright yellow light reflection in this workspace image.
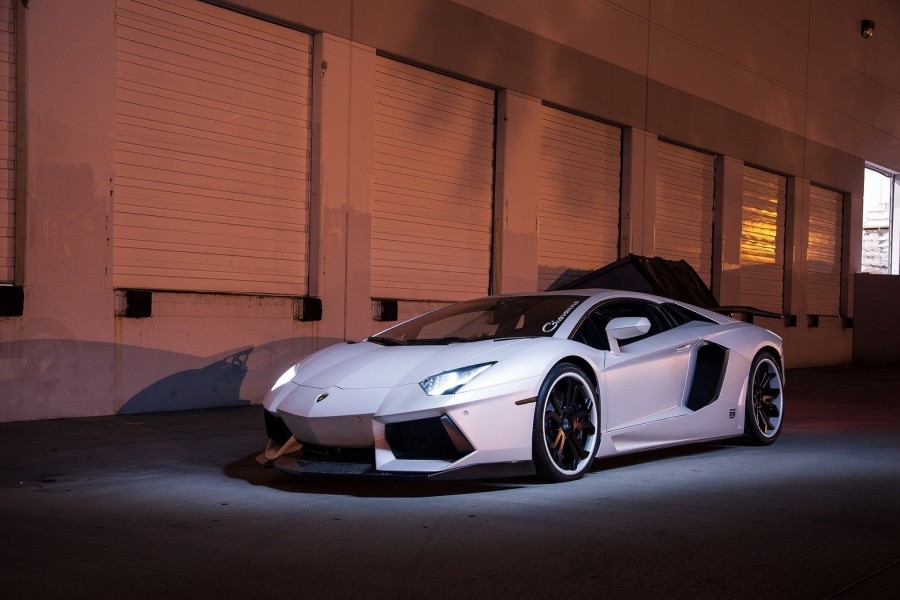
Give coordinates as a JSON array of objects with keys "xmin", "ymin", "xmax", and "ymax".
[{"xmin": 741, "ymin": 166, "xmax": 787, "ymax": 313}]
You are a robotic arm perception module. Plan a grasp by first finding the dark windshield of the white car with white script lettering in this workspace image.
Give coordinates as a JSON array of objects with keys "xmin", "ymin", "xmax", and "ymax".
[{"xmin": 369, "ymin": 296, "xmax": 584, "ymax": 345}]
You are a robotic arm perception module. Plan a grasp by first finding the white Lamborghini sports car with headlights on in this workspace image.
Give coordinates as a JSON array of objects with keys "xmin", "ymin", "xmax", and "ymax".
[{"xmin": 258, "ymin": 290, "xmax": 784, "ymax": 481}]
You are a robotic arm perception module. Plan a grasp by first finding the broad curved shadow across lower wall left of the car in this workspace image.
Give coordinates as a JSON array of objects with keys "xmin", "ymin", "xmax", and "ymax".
[{"xmin": 0, "ymin": 320, "xmax": 343, "ymax": 421}]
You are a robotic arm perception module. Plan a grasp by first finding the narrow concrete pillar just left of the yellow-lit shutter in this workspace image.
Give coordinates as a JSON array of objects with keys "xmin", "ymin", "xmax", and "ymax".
[{"xmin": 712, "ymin": 156, "xmax": 744, "ymax": 306}]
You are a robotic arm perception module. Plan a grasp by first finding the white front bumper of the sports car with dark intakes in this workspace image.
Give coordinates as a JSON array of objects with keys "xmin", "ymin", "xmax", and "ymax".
[{"xmin": 258, "ymin": 380, "xmax": 537, "ymax": 479}]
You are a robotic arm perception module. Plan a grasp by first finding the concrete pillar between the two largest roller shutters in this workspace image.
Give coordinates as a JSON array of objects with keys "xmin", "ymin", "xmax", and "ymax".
[{"xmin": 310, "ymin": 34, "xmax": 375, "ymax": 340}]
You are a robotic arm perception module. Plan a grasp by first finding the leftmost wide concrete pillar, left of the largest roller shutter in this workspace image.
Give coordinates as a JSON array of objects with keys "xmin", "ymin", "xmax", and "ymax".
[{"xmin": 0, "ymin": 2, "xmax": 116, "ymax": 421}]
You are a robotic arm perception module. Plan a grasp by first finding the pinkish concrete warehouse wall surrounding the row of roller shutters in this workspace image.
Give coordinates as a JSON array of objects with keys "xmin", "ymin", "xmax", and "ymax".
[{"xmin": 0, "ymin": 0, "xmax": 900, "ymax": 421}]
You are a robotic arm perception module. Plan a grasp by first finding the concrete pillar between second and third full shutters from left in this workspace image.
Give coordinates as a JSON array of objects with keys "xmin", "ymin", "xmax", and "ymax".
[{"xmin": 491, "ymin": 90, "xmax": 541, "ymax": 293}]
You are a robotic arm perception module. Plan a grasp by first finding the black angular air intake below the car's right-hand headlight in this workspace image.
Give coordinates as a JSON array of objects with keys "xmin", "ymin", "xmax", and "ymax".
[{"xmin": 385, "ymin": 415, "xmax": 475, "ymax": 462}]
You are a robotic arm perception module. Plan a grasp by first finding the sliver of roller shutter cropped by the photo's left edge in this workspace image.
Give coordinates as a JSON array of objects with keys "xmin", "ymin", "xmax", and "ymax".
[{"xmin": 0, "ymin": 0, "xmax": 16, "ymax": 283}]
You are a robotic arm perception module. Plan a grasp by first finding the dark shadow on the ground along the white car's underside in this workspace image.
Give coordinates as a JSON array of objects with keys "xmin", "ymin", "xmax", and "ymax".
[{"xmin": 223, "ymin": 440, "xmax": 735, "ymax": 498}]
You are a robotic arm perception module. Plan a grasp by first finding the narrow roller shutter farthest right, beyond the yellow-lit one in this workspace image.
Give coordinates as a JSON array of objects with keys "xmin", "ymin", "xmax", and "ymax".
[{"xmin": 806, "ymin": 185, "xmax": 844, "ymax": 316}]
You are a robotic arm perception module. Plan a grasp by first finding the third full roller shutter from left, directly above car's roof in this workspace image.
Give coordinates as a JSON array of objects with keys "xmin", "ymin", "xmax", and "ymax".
[{"xmin": 538, "ymin": 106, "xmax": 622, "ymax": 290}]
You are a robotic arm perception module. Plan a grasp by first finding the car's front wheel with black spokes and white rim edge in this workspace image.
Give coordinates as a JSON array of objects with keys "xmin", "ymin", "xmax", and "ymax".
[{"xmin": 532, "ymin": 363, "xmax": 600, "ymax": 482}]
